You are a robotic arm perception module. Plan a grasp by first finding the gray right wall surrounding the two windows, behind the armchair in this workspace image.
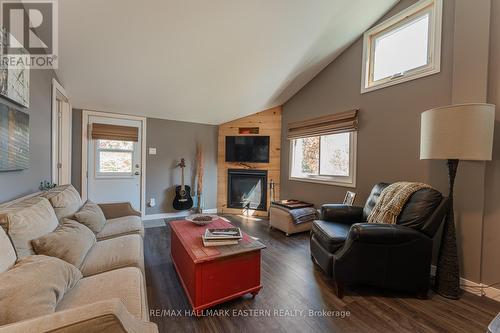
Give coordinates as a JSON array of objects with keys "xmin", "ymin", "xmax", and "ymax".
[{"xmin": 281, "ymin": 1, "xmax": 453, "ymax": 205}]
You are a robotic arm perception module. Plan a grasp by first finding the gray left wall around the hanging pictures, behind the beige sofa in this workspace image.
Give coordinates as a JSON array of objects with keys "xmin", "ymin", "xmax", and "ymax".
[{"xmin": 0, "ymin": 69, "xmax": 56, "ymax": 202}]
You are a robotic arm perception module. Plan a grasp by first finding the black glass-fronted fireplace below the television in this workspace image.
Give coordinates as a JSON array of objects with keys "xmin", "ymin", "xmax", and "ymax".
[{"xmin": 227, "ymin": 169, "xmax": 267, "ymax": 211}]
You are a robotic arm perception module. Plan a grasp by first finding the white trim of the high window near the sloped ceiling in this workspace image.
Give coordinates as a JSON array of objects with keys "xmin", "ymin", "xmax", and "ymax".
[{"xmin": 361, "ymin": 0, "xmax": 443, "ymax": 94}]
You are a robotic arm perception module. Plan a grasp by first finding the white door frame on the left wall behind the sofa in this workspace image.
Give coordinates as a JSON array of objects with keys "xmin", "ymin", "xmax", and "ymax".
[{"xmin": 52, "ymin": 81, "xmax": 72, "ymax": 185}]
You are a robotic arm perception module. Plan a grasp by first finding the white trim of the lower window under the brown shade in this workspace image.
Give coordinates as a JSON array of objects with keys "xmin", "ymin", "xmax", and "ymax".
[{"xmin": 288, "ymin": 132, "xmax": 358, "ymax": 188}]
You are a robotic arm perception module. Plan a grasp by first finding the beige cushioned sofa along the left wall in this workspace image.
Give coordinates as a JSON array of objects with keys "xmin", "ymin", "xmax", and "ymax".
[{"xmin": 0, "ymin": 185, "xmax": 157, "ymax": 333}]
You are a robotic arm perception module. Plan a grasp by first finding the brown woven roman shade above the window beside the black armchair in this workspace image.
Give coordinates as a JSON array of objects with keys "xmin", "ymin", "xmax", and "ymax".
[{"xmin": 287, "ymin": 109, "xmax": 359, "ymax": 140}]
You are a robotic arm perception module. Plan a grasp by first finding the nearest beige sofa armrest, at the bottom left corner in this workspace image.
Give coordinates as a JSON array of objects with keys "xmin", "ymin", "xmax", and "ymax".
[{"xmin": 0, "ymin": 299, "xmax": 158, "ymax": 333}]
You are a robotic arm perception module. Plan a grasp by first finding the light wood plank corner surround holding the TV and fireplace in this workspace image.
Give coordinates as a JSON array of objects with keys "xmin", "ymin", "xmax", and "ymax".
[{"xmin": 217, "ymin": 106, "xmax": 281, "ymax": 216}]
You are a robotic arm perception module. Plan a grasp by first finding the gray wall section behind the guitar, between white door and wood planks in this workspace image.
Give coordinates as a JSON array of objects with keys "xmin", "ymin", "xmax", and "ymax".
[{"xmin": 146, "ymin": 118, "xmax": 218, "ymax": 214}]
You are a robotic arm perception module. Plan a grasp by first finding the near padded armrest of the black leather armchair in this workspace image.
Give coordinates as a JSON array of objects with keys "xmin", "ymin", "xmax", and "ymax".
[{"xmin": 348, "ymin": 223, "xmax": 426, "ymax": 244}]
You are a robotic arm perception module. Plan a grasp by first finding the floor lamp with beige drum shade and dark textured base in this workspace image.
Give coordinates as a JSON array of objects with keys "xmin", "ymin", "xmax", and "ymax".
[{"xmin": 420, "ymin": 103, "xmax": 495, "ymax": 299}]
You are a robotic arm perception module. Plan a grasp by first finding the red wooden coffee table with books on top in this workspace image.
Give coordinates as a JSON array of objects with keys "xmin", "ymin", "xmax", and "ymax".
[{"xmin": 170, "ymin": 218, "xmax": 265, "ymax": 312}]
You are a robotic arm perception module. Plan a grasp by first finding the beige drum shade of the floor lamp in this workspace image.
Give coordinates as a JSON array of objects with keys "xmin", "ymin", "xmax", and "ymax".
[{"xmin": 420, "ymin": 103, "xmax": 495, "ymax": 161}]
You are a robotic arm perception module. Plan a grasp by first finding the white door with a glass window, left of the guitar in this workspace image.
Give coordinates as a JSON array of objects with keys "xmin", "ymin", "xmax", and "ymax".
[{"xmin": 87, "ymin": 116, "xmax": 142, "ymax": 211}]
